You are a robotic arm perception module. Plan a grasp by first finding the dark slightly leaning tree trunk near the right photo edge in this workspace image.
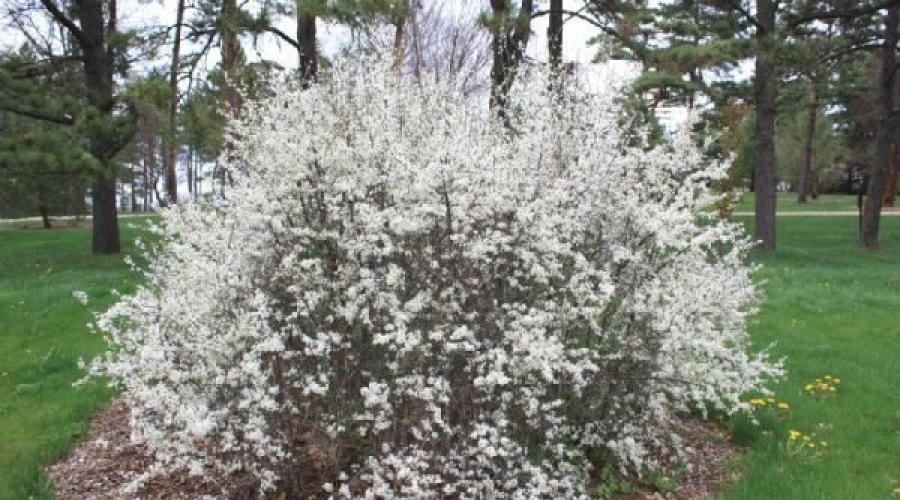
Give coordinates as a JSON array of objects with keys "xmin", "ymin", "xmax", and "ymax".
[{"xmin": 859, "ymin": 6, "xmax": 900, "ymax": 250}]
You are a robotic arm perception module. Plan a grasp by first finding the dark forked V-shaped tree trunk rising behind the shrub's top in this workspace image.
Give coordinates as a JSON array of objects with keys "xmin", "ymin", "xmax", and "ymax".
[{"xmin": 490, "ymin": 0, "xmax": 534, "ymax": 122}]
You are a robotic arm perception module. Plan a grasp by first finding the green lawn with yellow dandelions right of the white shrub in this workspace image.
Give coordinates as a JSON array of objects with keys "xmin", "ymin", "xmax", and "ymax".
[{"xmin": 725, "ymin": 217, "xmax": 900, "ymax": 500}]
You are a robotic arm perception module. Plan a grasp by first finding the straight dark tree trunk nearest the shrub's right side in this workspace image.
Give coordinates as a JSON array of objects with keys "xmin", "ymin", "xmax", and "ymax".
[{"xmin": 753, "ymin": 0, "xmax": 777, "ymax": 250}]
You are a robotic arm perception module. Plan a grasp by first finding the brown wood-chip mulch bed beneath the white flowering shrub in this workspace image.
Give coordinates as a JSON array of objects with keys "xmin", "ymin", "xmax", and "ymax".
[{"xmin": 48, "ymin": 401, "xmax": 738, "ymax": 500}]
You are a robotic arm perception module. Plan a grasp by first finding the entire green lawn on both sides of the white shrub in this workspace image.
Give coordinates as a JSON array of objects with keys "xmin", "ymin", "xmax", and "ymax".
[{"xmin": 0, "ymin": 217, "xmax": 900, "ymax": 500}]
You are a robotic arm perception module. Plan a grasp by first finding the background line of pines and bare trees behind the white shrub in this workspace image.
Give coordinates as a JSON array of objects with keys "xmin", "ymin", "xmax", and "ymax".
[{"xmin": 0, "ymin": 0, "xmax": 900, "ymax": 253}]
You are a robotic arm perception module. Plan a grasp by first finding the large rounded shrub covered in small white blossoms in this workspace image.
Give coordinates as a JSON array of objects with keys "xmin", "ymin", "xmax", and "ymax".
[{"xmin": 92, "ymin": 60, "xmax": 780, "ymax": 498}]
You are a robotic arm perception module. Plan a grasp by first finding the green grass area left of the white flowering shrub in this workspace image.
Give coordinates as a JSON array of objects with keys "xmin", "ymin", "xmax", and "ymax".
[{"xmin": 0, "ymin": 224, "xmax": 143, "ymax": 500}]
